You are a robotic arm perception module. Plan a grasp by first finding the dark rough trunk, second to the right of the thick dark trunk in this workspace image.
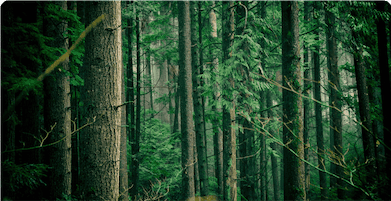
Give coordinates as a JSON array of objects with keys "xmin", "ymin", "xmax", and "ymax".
[{"xmin": 326, "ymin": 8, "xmax": 343, "ymax": 199}]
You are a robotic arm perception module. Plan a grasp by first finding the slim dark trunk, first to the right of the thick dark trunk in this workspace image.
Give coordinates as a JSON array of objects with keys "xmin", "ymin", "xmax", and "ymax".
[{"xmin": 312, "ymin": 2, "xmax": 328, "ymax": 200}]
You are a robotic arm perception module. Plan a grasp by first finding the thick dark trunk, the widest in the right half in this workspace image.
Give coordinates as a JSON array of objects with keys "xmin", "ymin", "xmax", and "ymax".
[{"xmin": 281, "ymin": 0, "xmax": 306, "ymax": 200}]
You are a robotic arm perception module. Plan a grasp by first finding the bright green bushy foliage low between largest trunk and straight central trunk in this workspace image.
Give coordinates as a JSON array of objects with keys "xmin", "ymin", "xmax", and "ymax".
[{"xmin": 128, "ymin": 111, "xmax": 181, "ymax": 200}]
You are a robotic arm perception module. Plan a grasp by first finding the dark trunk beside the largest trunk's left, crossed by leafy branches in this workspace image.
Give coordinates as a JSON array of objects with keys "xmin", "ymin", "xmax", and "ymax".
[{"xmin": 44, "ymin": 0, "xmax": 71, "ymax": 199}]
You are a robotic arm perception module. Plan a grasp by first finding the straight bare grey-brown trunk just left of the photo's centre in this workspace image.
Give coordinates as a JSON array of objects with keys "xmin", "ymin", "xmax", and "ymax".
[{"xmin": 178, "ymin": 0, "xmax": 195, "ymax": 200}]
